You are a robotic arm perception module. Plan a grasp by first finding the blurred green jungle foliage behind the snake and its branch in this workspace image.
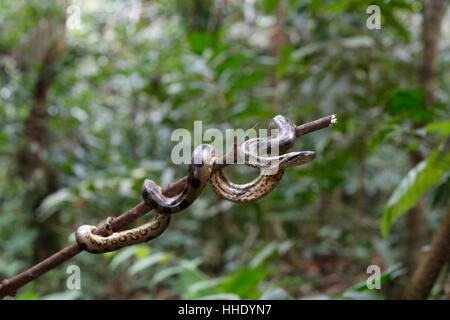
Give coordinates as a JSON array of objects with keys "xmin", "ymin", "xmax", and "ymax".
[{"xmin": 0, "ymin": 0, "xmax": 450, "ymax": 299}]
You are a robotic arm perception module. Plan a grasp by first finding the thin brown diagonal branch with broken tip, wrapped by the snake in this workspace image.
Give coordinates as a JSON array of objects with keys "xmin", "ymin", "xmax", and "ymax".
[{"xmin": 0, "ymin": 115, "xmax": 336, "ymax": 299}]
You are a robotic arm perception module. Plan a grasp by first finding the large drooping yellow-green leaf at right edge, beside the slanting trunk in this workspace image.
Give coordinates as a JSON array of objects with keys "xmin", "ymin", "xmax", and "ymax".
[{"xmin": 381, "ymin": 150, "xmax": 450, "ymax": 237}]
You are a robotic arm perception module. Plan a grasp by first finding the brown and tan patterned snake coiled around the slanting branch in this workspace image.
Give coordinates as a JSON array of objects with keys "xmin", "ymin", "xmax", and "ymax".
[{"xmin": 75, "ymin": 115, "xmax": 315, "ymax": 253}]
